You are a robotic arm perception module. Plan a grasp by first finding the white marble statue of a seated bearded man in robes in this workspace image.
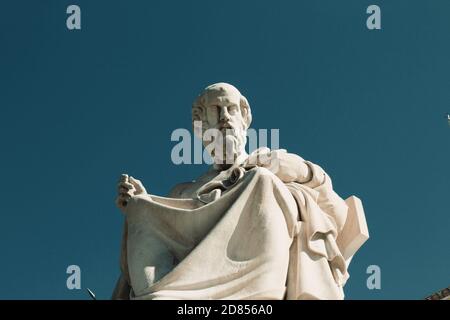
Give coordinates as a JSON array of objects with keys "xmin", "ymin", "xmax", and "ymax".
[{"xmin": 113, "ymin": 83, "xmax": 368, "ymax": 300}]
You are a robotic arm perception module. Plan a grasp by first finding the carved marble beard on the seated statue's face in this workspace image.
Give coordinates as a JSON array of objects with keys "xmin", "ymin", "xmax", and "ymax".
[{"xmin": 204, "ymin": 123, "xmax": 247, "ymax": 165}]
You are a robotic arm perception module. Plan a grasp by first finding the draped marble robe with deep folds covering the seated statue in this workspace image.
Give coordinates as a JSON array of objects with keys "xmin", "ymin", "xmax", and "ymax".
[{"xmin": 115, "ymin": 151, "xmax": 348, "ymax": 299}]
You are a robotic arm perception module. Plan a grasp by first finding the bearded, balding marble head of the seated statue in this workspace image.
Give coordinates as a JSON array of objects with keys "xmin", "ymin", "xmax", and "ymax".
[{"xmin": 192, "ymin": 82, "xmax": 252, "ymax": 165}]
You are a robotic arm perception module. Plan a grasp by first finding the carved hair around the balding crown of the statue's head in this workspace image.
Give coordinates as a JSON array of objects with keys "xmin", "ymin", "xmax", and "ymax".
[{"xmin": 192, "ymin": 84, "xmax": 252, "ymax": 138}]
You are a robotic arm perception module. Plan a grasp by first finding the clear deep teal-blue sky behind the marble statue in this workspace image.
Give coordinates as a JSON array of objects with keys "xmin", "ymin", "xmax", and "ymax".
[{"xmin": 0, "ymin": 0, "xmax": 450, "ymax": 299}]
